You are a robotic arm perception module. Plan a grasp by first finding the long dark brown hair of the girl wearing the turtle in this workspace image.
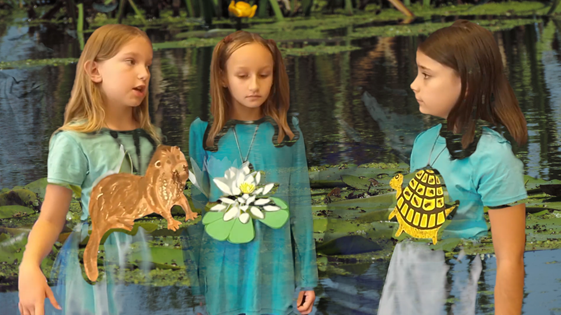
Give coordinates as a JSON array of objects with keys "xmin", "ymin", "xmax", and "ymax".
[{"xmin": 418, "ymin": 20, "xmax": 528, "ymax": 149}]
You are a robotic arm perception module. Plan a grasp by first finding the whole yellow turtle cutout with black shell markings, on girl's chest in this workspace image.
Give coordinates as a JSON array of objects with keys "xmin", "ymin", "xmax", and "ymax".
[{"xmin": 389, "ymin": 167, "xmax": 459, "ymax": 244}]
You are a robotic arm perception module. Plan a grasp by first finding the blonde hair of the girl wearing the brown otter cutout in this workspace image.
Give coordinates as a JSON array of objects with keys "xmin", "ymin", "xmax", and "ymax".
[{"xmin": 55, "ymin": 24, "xmax": 160, "ymax": 142}]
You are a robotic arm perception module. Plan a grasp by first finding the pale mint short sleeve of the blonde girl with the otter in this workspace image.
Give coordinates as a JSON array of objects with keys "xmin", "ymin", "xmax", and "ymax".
[{"xmin": 47, "ymin": 131, "xmax": 88, "ymax": 187}]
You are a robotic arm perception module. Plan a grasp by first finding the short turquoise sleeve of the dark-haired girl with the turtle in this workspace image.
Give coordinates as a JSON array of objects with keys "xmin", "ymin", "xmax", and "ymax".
[{"xmin": 472, "ymin": 137, "xmax": 528, "ymax": 207}]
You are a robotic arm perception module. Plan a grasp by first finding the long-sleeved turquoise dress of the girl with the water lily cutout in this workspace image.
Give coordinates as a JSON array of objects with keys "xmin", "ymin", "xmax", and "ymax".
[{"xmin": 184, "ymin": 117, "xmax": 318, "ymax": 315}]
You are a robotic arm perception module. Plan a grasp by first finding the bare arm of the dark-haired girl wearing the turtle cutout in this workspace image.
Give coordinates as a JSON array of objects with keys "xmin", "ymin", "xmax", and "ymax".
[{"xmin": 489, "ymin": 204, "xmax": 526, "ymax": 315}]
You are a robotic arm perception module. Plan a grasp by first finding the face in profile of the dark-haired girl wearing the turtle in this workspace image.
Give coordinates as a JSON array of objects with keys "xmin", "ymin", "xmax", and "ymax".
[{"xmin": 411, "ymin": 50, "xmax": 462, "ymax": 119}]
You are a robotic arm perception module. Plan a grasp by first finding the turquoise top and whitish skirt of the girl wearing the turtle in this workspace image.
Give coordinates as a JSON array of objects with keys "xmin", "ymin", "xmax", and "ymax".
[{"xmin": 378, "ymin": 124, "xmax": 528, "ymax": 315}]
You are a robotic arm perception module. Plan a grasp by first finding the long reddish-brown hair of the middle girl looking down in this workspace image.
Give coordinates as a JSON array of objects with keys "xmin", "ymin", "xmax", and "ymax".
[{"xmin": 206, "ymin": 31, "xmax": 294, "ymax": 147}]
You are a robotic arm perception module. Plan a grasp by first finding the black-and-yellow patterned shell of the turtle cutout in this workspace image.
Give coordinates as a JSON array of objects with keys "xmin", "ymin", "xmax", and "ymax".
[{"xmin": 397, "ymin": 169, "xmax": 446, "ymax": 230}]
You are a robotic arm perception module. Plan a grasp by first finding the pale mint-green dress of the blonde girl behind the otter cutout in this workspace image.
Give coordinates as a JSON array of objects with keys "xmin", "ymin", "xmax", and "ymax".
[{"xmin": 47, "ymin": 129, "xmax": 156, "ymax": 315}]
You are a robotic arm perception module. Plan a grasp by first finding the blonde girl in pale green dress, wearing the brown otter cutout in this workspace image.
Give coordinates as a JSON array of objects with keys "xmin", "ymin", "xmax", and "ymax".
[{"xmin": 19, "ymin": 24, "xmax": 159, "ymax": 315}]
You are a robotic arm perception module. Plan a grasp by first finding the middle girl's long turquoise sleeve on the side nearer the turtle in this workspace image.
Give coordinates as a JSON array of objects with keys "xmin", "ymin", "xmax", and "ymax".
[{"xmin": 289, "ymin": 118, "xmax": 318, "ymax": 290}]
